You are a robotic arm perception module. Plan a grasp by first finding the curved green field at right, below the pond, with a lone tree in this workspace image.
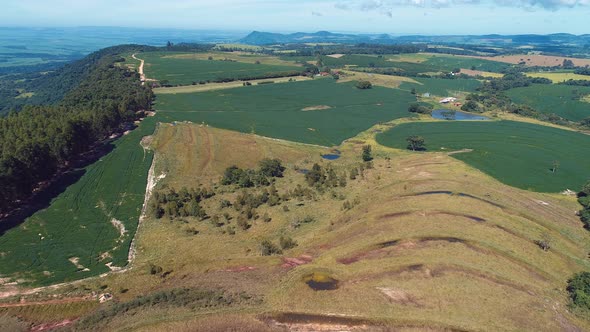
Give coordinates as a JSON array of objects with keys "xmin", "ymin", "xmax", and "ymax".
[{"xmin": 377, "ymin": 121, "xmax": 590, "ymax": 192}]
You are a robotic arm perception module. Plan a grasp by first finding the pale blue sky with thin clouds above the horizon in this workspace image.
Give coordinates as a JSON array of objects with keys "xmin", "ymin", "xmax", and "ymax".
[{"xmin": 0, "ymin": 0, "xmax": 590, "ymax": 34}]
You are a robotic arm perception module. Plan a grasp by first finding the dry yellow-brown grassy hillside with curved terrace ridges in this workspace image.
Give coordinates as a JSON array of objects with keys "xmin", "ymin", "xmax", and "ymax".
[{"xmin": 51, "ymin": 123, "xmax": 589, "ymax": 331}]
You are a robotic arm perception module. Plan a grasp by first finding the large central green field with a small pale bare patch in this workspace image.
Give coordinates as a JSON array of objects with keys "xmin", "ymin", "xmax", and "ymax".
[{"xmin": 156, "ymin": 79, "xmax": 415, "ymax": 146}]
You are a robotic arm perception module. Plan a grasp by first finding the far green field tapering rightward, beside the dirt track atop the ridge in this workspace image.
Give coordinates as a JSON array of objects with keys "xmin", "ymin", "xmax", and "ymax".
[{"xmin": 139, "ymin": 52, "xmax": 302, "ymax": 85}]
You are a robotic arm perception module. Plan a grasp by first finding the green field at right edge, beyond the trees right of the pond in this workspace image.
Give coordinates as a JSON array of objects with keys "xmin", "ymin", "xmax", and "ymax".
[{"xmin": 506, "ymin": 84, "xmax": 590, "ymax": 121}]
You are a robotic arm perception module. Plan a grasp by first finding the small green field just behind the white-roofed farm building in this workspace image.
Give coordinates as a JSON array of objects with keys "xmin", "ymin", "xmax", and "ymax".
[{"xmin": 400, "ymin": 78, "xmax": 481, "ymax": 96}]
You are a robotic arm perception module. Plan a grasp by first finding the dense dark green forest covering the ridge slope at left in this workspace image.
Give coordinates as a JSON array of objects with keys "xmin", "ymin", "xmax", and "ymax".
[{"xmin": 0, "ymin": 45, "xmax": 153, "ymax": 214}]
